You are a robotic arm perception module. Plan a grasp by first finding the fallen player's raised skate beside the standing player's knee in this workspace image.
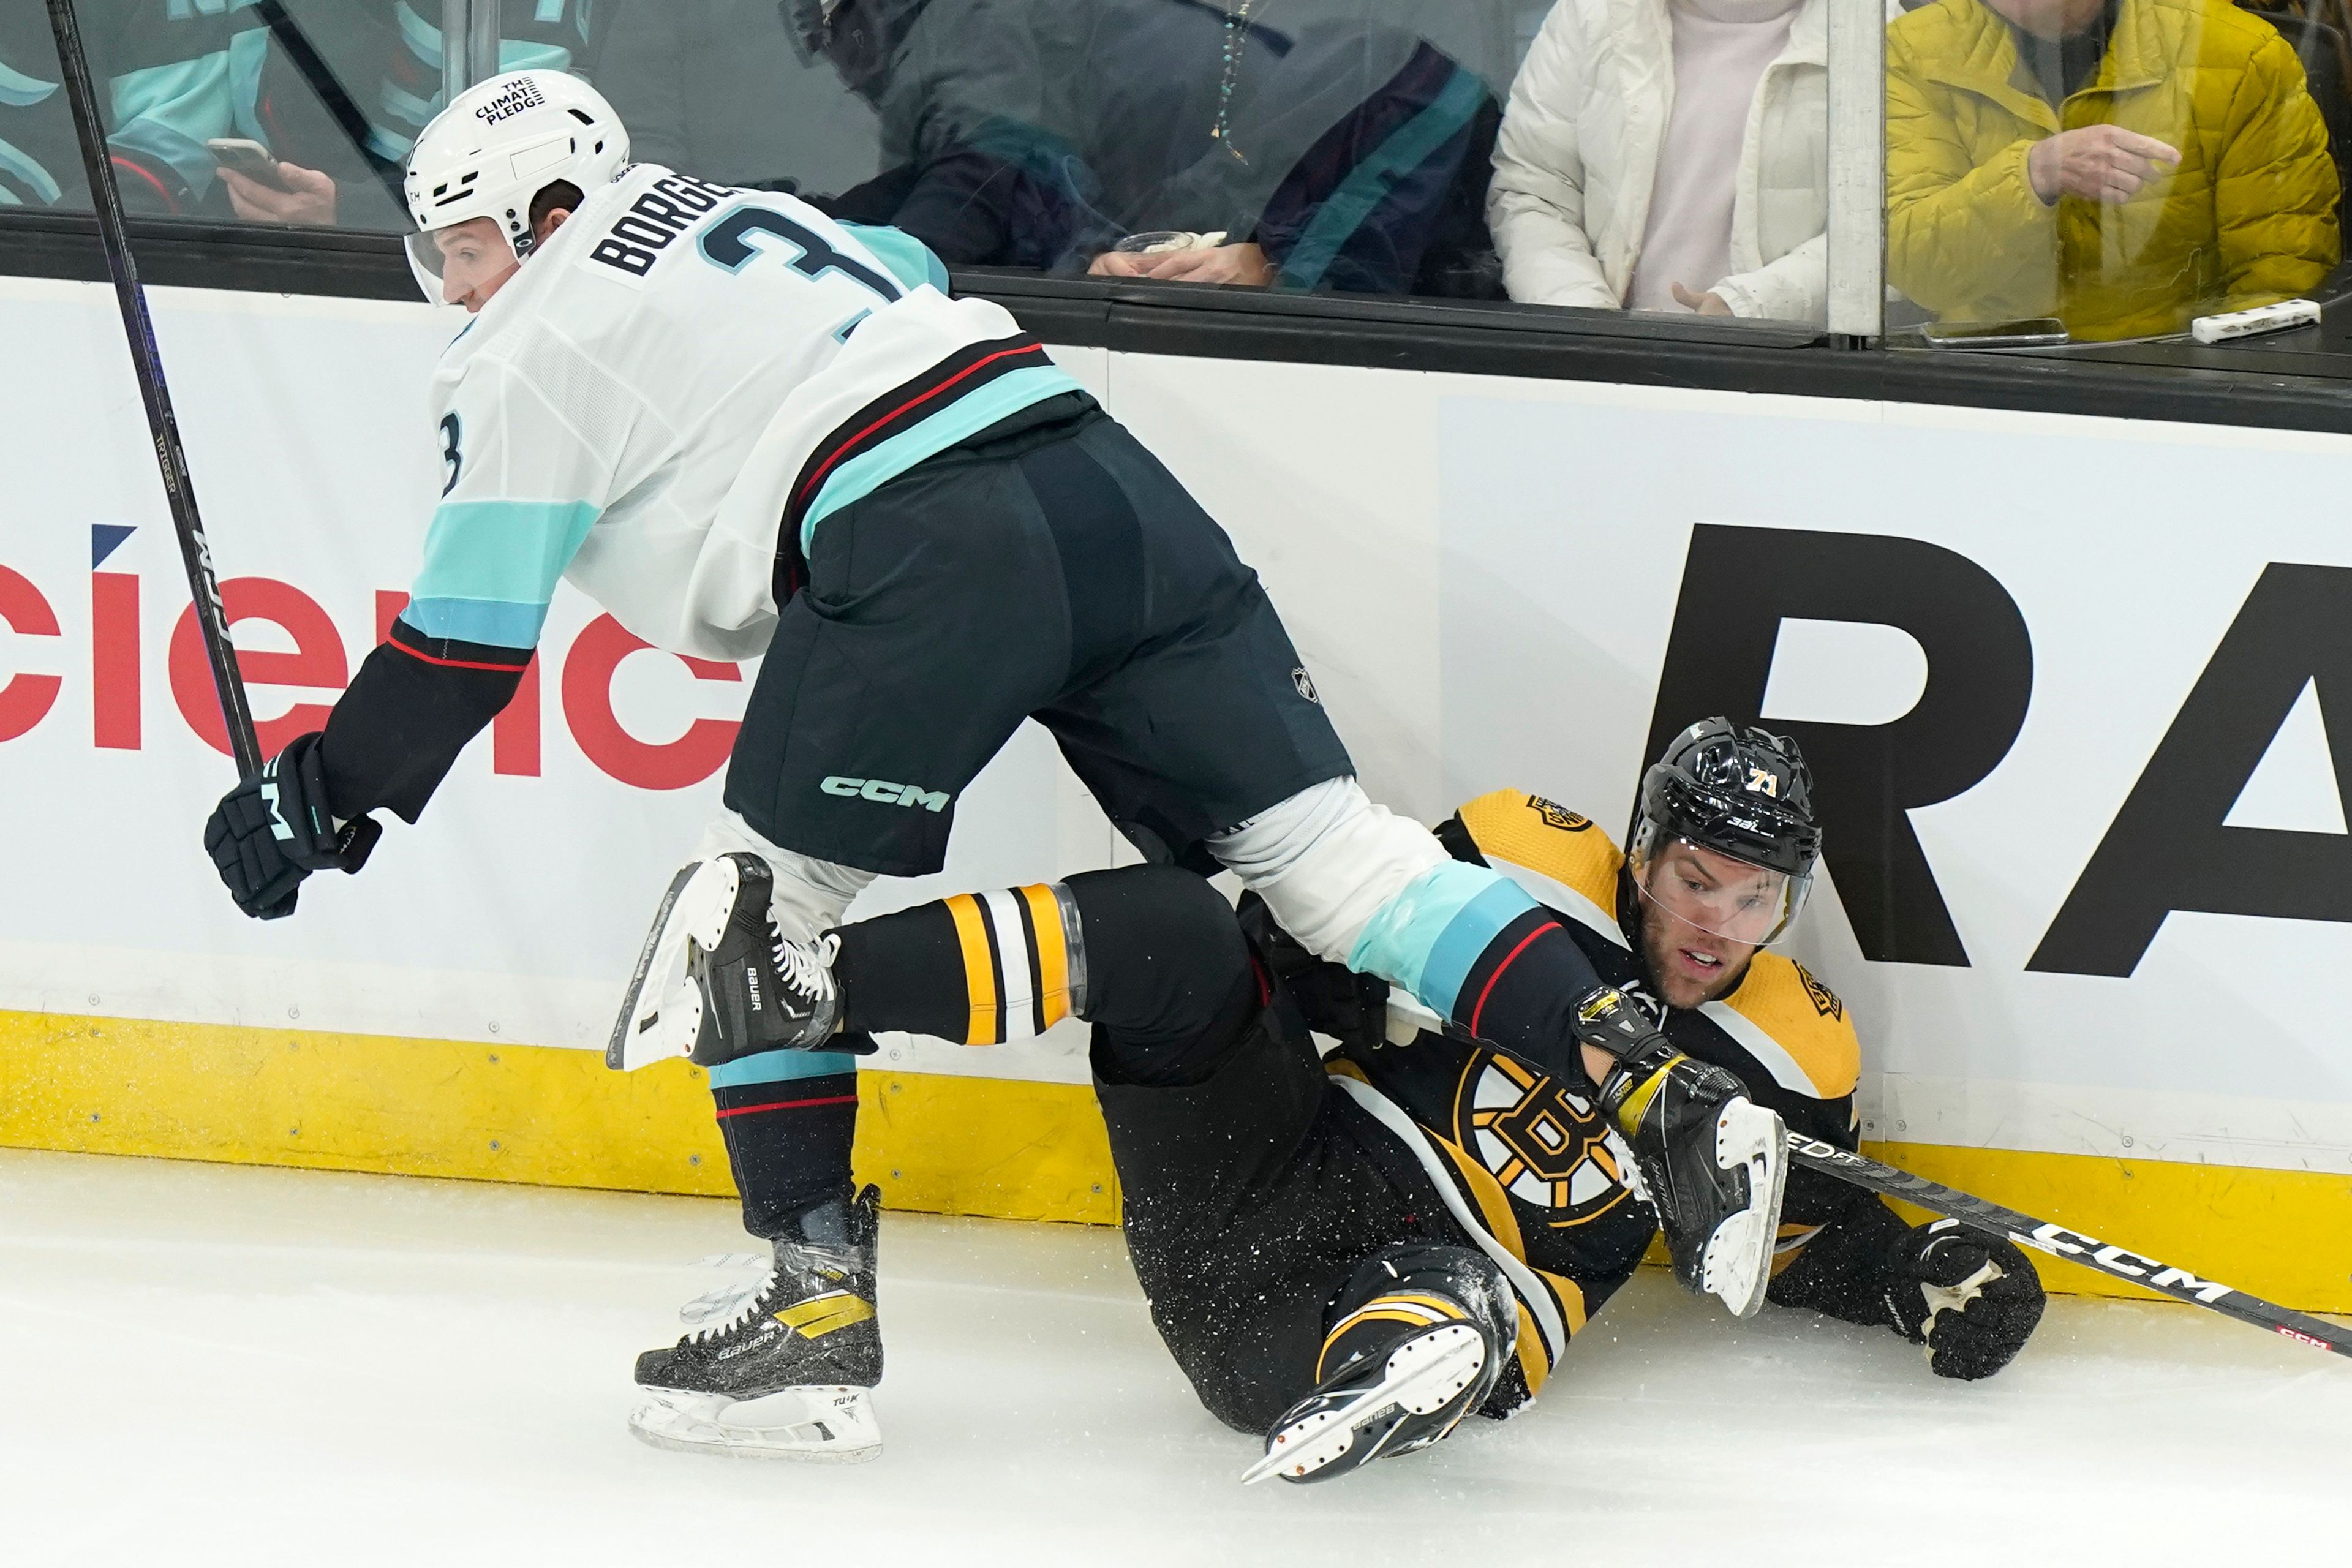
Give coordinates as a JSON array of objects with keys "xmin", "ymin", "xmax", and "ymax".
[{"xmin": 605, "ymin": 853, "xmax": 842, "ymax": 1072}]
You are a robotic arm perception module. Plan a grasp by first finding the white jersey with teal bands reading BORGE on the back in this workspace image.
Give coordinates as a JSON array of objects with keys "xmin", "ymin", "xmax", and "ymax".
[{"xmin": 402, "ymin": 165, "xmax": 1077, "ymax": 661}]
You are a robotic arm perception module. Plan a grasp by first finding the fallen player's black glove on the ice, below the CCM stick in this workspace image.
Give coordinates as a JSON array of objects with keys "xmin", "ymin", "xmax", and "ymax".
[{"xmin": 1887, "ymin": 1220, "xmax": 2041, "ymax": 1380}]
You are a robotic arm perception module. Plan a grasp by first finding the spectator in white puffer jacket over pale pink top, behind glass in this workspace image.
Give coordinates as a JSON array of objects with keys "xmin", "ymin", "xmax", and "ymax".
[{"xmin": 1487, "ymin": 0, "xmax": 1830, "ymax": 322}]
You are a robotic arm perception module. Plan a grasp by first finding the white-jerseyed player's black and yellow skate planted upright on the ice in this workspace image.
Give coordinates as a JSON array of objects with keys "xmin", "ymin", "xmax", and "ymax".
[{"xmin": 628, "ymin": 1187, "xmax": 882, "ymax": 1464}]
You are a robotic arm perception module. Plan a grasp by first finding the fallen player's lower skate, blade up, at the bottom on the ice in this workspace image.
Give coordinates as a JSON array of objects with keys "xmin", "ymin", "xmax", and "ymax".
[{"xmin": 1242, "ymin": 1243, "xmax": 1520, "ymax": 1486}]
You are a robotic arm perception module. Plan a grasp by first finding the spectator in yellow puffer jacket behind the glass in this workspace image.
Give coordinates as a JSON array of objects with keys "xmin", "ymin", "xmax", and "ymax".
[{"xmin": 1887, "ymin": 0, "xmax": 2338, "ymax": 339}]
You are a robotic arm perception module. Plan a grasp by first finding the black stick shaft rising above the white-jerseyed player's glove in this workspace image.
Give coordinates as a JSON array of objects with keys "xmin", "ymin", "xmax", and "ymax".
[{"xmin": 50, "ymin": 0, "xmax": 261, "ymax": 776}]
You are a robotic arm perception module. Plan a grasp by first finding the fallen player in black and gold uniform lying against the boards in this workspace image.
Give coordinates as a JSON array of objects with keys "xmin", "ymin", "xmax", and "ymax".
[{"xmin": 658, "ymin": 719, "xmax": 2041, "ymax": 1481}]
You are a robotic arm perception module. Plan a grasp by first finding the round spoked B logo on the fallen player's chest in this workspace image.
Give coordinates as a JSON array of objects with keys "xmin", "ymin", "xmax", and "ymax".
[{"xmin": 1453, "ymin": 1051, "xmax": 1632, "ymax": 1229}]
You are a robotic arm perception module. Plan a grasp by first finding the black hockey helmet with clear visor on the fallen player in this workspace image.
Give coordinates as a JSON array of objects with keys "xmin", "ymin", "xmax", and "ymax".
[{"xmin": 1621, "ymin": 719, "xmax": 1820, "ymax": 948}]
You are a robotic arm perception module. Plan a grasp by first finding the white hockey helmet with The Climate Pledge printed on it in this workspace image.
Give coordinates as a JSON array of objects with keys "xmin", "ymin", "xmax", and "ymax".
[{"xmin": 407, "ymin": 70, "xmax": 628, "ymax": 306}]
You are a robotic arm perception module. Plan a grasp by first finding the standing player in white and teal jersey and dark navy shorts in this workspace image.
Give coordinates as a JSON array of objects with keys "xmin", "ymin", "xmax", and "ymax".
[{"xmin": 205, "ymin": 70, "xmax": 1783, "ymax": 1460}]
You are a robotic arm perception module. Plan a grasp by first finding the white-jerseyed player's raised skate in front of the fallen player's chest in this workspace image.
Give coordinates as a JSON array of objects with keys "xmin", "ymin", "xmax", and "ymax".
[{"xmin": 1576, "ymin": 987, "xmax": 1787, "ymax": 1316}]
